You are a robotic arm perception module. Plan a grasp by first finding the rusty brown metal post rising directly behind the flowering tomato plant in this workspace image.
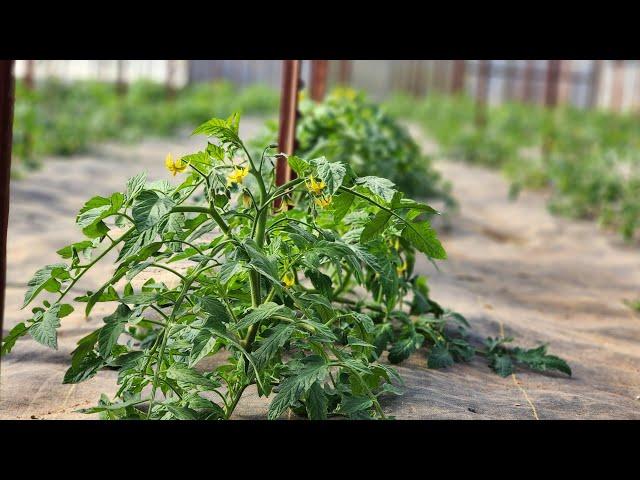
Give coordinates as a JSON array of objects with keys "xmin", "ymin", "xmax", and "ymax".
[{"xmin": 274, "ymin": 60, "xmax": 302, "ymax": 208}]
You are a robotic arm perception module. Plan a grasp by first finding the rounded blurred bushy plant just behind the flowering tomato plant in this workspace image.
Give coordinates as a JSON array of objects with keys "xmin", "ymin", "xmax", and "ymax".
[{"xmin": 251, "ymin": 87, "xmax": 455, "ymax": 207}]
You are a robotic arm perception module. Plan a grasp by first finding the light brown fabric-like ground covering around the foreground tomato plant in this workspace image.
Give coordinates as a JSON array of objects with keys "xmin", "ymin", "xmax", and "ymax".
[{"xmin": 0, "ymin": 119, "xmax": 640, "ymax": 419}]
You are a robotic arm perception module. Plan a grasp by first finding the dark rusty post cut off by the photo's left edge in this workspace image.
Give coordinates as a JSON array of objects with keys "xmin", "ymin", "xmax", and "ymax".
[{"xmin": 0, "ymin": 60, "xmax": 14, "ymax": 356}]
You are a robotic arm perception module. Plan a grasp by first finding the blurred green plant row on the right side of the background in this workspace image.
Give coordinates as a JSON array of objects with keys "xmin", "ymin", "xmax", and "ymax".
[{"xmin": 387, "ymin": 94, "xmax": 640, "ymax": 240}]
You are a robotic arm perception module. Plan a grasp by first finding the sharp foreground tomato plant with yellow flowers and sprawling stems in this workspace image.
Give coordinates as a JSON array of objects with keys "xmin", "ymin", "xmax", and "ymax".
[{"xmin": 2, "ymin": 115, "xmax": 571, "ymax": 419}]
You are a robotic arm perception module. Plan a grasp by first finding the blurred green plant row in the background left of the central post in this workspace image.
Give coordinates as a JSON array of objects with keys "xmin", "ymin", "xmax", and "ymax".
[{"xmin": 13, "ymin": 79, "xmax": 279, "ymax": 173}]
